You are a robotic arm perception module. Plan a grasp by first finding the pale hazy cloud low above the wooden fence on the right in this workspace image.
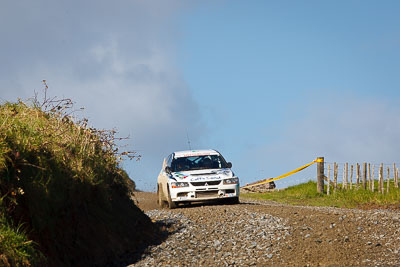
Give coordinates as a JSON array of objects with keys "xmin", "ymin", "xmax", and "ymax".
[{"xmin": 241, "ymin": 93, "xmax": 400, "ymax": 187}]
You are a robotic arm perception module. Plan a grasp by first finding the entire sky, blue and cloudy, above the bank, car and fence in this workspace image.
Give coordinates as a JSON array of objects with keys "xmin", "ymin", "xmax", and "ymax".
[{"xmin": 0, "ymin": 0, "xmax": 400, "ymax": 190}]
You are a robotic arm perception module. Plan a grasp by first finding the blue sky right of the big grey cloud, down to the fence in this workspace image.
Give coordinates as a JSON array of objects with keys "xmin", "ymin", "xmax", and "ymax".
[{"xmin": 179, "ymin": 1, "xmax": 400, "ymax": 191}]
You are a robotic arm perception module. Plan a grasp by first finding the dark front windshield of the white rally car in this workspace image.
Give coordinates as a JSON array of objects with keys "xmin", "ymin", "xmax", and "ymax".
[{"xmin": 171, "ymin": 155, "xmax": 227, "ymax": 172}]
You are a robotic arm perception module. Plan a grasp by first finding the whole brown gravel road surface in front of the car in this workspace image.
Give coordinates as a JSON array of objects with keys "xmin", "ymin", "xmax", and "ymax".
[{"xmin": 132, "ymin": 192, "xmax": 400, "ymax": 266}]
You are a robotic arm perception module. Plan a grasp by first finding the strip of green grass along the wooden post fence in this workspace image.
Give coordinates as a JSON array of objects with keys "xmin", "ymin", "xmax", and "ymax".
[{"xmin": 241, "ymin": 181, "xmax": 400, "ymax": 208}]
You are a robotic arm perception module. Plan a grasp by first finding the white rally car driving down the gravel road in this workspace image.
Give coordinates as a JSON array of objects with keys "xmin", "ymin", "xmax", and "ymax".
[{"xmin": 157, "ymin": 150, "xmax": 239, "ymax": 209}]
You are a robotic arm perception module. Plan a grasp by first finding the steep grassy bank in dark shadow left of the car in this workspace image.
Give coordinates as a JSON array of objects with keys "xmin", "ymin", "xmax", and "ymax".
[{"xmin": 0, "ymin": 99, "xmax": 158, "ymax": 266}]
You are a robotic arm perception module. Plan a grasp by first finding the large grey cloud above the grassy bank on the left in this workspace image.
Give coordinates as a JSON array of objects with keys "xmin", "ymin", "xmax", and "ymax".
[{"xmin": 0, "ymin": 0, "xmax": 202, "ymax": 191}]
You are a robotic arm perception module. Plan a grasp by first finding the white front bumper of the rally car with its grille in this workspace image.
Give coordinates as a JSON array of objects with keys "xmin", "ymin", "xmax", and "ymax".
[{"xmin": 169, "ymin": 180, "xmax": 240, "ymax": 202}]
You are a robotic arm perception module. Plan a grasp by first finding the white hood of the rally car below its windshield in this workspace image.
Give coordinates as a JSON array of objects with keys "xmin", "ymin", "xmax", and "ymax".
[{"xmin": 170, "ymin": 168, "xmax": 233, "ymax": 182}]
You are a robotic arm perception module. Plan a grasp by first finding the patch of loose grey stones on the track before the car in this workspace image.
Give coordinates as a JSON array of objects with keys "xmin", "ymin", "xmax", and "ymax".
[{"xmin": 137, "ymin": 205, "xmax": 290, "ymax": 266}]
